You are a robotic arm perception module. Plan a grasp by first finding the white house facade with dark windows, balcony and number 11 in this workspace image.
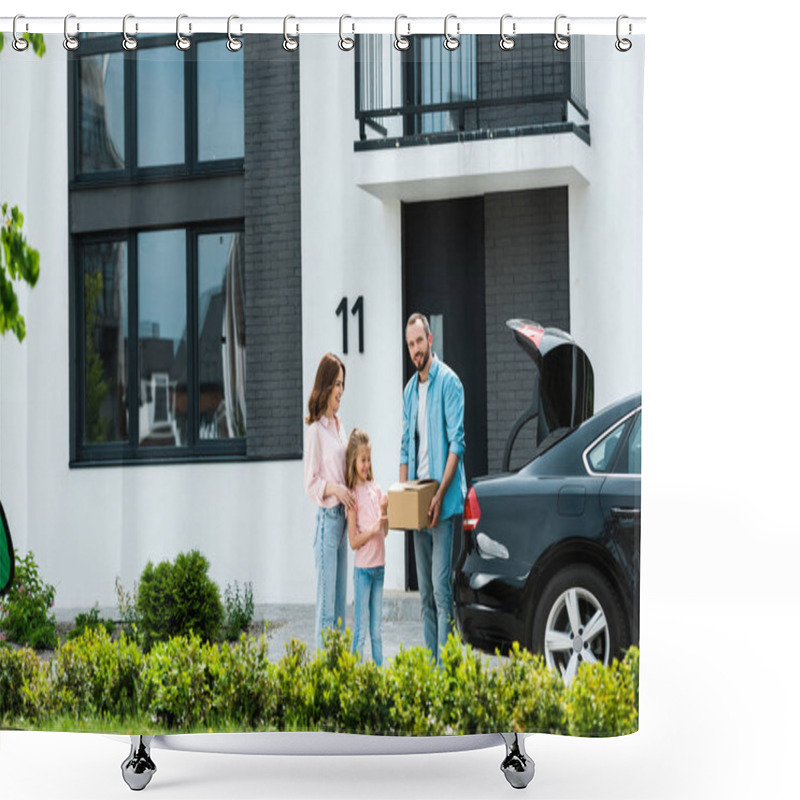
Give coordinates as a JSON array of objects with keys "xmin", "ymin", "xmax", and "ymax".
[{"xmin": 0, "ymin": 36, "xmax": 643, "ymax": 615}]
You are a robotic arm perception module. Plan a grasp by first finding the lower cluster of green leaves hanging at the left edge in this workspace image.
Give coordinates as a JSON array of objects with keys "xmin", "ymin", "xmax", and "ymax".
[{"xmin": 0, "ymin": 203, "xmax": 39, "ymax": 342}]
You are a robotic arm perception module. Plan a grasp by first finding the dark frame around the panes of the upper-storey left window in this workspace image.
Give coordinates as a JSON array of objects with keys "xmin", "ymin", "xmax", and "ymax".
[{"xmin": 68, "ymin": 34, "xmax": 244, "ymax": 188}]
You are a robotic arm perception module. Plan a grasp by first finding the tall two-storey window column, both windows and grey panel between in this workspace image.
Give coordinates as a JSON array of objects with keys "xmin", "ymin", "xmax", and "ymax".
[{"xmin": 69, "ymin": 35, "xmax": 247, "ymax": 463}]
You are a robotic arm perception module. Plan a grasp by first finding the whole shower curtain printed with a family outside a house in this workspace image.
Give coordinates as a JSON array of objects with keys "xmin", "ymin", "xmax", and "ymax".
[{"xmin": 0, "ymin": 27, "xmax": 644, "ymax": 736}]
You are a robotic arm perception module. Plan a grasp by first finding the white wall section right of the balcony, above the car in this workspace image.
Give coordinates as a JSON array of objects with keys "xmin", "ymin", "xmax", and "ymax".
[{"xmin": 569, "ymin": 36, "xmax": 644, "ymax": 410}]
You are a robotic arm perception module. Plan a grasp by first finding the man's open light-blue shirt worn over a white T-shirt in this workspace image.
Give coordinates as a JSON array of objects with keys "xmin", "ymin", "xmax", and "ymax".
[{"xmin": 400, "ymin": 356, "xmax": 467, "ymax": 519}]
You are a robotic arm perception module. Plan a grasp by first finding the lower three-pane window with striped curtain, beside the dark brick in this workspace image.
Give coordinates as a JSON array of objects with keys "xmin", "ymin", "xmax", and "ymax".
[{"xmin": 78, "ymin": 227, "xmax": 247, "ymax": 460}]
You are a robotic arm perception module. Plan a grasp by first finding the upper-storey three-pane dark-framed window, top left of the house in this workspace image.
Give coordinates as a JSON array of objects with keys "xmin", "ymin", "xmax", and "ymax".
[{"xmin": 70, "ymin": 35, "xmax": 244, "ymax": 182}]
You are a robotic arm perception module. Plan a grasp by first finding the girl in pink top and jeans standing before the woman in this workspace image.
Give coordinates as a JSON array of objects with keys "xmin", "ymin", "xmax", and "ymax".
[{"xmin": 347, "ymin": 428, "xmax": 389, "ymax": 666}]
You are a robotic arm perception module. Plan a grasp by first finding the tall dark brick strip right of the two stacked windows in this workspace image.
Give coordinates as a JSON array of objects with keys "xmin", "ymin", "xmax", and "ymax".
[{"xmin": 244, "ymin": 36, "xmax": 303, "ymax": 458}]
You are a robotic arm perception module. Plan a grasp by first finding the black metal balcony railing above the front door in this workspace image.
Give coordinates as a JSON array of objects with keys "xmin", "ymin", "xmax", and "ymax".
[{"xmin": 355, "ymin": 36, "xmax": 588, "ymax": 149}]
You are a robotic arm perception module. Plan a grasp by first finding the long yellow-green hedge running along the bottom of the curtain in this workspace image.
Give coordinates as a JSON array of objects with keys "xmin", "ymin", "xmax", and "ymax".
[{"xmin": 0, "ymin": 628, "xmax": 639, "ymax": 736}]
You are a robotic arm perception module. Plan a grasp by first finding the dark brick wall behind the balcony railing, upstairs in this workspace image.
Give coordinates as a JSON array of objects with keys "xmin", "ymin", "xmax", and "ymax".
[{"xmin": 476, "ymin": 31, "xmax": 570, "ymax": 129}]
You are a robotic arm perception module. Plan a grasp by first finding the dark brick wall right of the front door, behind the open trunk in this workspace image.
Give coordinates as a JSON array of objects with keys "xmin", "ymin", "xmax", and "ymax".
[{"xmin": 484, "ymin": 188, "xmax": 570, "ymax": 473}]
